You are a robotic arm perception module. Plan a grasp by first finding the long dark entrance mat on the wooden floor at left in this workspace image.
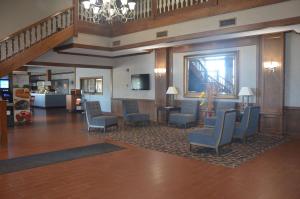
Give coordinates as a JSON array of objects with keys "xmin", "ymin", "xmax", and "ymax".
[{"xmin": 0, "ymin": 143, "xmax": 124, "ymax": 174}]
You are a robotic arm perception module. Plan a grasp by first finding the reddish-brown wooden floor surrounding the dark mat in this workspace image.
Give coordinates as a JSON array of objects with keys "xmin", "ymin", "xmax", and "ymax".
[{"xmin": 0, "ymin": 110, "xmax": 300, "ymax": 199}]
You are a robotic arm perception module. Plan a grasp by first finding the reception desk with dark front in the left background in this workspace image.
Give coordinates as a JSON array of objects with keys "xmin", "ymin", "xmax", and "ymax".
[{"xmin": 31, "ymin": 93, "xmax": 66, "ymax": 108}]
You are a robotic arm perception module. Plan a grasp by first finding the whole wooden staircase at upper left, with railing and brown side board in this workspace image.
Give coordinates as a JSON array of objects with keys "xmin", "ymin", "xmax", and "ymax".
[{"xmin": 0, "ymin": 7, "xmax": 74, "ymax": 77}]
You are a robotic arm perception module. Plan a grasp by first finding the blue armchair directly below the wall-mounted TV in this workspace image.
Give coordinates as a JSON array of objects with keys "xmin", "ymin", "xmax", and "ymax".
[{"xmin": 122, "ymin": 100, "xmax": 150, "ymax": 124}]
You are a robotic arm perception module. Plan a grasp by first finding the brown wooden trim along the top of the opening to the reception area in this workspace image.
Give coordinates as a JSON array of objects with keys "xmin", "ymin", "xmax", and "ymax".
[{"xmin": 26, "ymin": 61, "xmax": 113, "ymax": 69}]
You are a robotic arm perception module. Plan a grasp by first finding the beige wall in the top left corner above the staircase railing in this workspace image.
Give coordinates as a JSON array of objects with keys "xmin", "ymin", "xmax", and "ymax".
[{"xmin": 0, "ymin": 0, "xmax": 72, "ymax": 39}]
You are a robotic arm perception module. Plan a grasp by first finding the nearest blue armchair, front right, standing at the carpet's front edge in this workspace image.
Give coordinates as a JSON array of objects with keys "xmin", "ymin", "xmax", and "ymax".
[{"xmin": 188, "ymin": 110, "xmax": 236, "ymax": 155}]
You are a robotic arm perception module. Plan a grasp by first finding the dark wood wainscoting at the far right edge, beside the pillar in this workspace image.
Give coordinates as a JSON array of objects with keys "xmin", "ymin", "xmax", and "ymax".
[{"xmin": 284, "ymin": 106, "xmax": 300, "ymax": 137}]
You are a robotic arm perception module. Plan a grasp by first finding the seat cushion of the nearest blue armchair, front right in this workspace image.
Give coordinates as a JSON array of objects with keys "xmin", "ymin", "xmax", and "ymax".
[{"xmin": 188, "ymin": 128, "xmax": 217, "ymax": 146}]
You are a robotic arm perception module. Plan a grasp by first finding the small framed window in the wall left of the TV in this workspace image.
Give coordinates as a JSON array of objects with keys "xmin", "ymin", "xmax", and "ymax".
[{"xmin": 80, "ymin": 77, "xmax": 103, "ymax": 95}]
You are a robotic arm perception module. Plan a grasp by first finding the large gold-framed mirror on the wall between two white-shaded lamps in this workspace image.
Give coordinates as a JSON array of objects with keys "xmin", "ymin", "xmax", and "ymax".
[{"xmin": 184, "ymin": 52, "xmax": 238, "ymax": 98}]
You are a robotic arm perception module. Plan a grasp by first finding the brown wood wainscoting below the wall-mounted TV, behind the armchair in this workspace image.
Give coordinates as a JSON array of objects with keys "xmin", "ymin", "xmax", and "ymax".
[{"xmin": 112, "ymin": 98, "xmax": 156, "ymax": 121}]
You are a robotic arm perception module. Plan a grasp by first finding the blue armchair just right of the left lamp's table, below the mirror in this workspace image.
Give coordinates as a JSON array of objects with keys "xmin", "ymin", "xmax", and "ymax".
[{"xmin": 168, "ymin": 100, "xmax": 199, "ymax": 128}]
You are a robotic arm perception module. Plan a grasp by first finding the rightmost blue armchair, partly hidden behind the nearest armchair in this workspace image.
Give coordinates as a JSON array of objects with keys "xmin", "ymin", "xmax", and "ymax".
[{"xmin": 233, "ymin": 106, "xmax": 260, "ymax": 143}]
